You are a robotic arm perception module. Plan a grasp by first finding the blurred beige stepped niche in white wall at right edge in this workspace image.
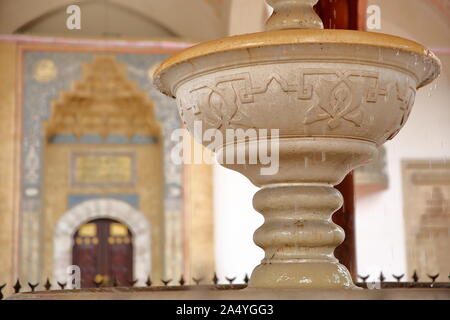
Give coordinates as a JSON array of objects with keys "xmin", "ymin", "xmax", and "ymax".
[{"xmin": 403, "ymin": 159, "xmax": 450, "ymax": 281}]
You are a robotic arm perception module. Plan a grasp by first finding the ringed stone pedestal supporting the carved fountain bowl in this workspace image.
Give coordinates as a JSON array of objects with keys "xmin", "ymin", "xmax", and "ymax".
[{"xmin": 223, "ymin": 137, "xmax": 377, "ymax": 288}]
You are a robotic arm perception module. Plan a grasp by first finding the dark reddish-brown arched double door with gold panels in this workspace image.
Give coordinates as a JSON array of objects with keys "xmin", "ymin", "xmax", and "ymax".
[{"xmin": 72, "ymin": 219, "xmax": 133, "ymax": 288}]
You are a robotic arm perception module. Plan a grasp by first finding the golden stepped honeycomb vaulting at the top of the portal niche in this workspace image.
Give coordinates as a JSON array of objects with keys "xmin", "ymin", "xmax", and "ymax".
[{"xmin": 46, "ymin": 56, "xmax": 161, "ymax": 143}]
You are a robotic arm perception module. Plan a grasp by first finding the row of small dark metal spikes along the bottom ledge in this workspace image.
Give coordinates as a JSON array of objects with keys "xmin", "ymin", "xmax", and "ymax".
[{"xmin": 0, "ymin": 272, "xmax": 450, "ymax": 300}]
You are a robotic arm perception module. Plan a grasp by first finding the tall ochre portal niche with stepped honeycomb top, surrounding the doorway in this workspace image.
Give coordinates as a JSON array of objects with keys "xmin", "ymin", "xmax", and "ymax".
[{"xmin": 44, "ymin": 56, "xmax": 164, "ymax": 285}]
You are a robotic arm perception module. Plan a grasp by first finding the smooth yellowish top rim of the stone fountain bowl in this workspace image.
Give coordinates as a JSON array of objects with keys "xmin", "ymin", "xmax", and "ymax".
[{"xmin": 153, "ymin": 29, "xmax": 442, "ymax": 97}]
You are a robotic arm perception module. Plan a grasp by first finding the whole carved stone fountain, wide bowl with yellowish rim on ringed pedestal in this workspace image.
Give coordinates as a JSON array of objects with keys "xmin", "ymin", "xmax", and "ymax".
[{"xmin": 154, "ymin": 1, "xmax": 440, "ymax": 288}]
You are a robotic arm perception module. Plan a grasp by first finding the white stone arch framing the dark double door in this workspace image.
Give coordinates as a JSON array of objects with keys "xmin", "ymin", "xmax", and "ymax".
[{"xmin": 53, "ymin": 198, "xmax": 151, "ymax": 283}]
